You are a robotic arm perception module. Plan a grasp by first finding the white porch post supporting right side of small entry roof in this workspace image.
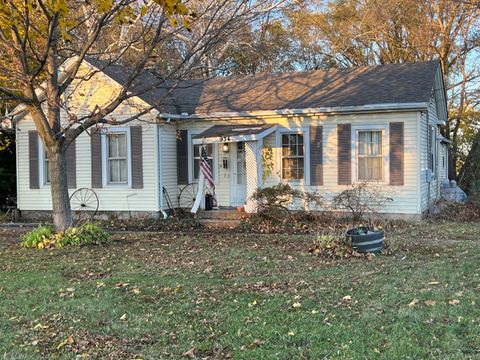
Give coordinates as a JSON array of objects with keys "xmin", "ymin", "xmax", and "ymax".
[{"xmin": 245, "ymin": 140, "xmax": 263, "ymax": 213}]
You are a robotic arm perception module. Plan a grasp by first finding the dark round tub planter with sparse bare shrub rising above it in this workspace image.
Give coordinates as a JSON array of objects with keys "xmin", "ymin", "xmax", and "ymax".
[{"xmin": 333, "ymin": 183, "xmax": 393, "ymax": 253}]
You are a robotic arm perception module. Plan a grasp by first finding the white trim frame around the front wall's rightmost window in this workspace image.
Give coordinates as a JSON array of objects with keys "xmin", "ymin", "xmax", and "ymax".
[{"xmin": 351, "ymin": 124, "xmax": 390, "ymax": 185}]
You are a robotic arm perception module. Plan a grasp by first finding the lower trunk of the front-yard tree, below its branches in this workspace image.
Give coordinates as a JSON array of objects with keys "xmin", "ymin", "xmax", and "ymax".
[{"xmin": 48, "ymin": 150, "xmax": 72, "ymax": 232}]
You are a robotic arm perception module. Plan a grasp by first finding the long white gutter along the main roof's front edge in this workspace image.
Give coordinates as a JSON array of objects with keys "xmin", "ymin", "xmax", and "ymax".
[{"xmin": 158, "ymin": 102, "xmax": 428, "ymax": 120}]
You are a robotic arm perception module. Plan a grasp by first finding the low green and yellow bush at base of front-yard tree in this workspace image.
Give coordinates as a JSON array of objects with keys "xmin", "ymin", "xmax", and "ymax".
[{"xmin": 20, "ymin": 223, "xmax": 110, "ymax": 249}]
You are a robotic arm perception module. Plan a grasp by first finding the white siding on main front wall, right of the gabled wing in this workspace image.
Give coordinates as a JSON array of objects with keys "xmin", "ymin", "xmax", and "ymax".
[{"xmin": 182, "ymin": 112, "xmax": 419, "ymax": 214}]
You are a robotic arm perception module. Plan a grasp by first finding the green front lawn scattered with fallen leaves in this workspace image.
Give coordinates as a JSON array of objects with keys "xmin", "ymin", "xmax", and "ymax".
[{"xmin": 0, "ymin": 222, "xmax": 480, "ymax": 359}]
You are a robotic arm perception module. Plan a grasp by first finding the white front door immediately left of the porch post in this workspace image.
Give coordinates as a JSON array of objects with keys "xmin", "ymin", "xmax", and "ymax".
[{"xmin": 231, "ymin": 142, "xmax": 247, "ymax": 206}]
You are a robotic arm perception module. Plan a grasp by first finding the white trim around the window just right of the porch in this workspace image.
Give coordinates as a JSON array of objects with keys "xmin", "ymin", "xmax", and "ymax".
[{"xmin": 275, "ymin": 127, "xmax": 310, "ymax": 186}]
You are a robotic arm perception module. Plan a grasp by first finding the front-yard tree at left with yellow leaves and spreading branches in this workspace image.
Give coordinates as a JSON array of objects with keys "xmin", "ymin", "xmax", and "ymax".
[{"xmin": 0, "ymin": 0, "xmax": 282, "ymax": 231}]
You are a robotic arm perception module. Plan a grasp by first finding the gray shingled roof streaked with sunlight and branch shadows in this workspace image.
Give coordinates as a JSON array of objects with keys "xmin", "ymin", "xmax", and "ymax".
[{"xmin": 85, "ymin": 60, "xmax": 439, "ymax": 115}]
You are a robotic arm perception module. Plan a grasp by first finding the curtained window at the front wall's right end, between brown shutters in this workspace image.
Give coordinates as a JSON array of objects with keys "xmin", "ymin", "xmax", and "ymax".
[{"xmin": 357, "ymin": 130, "xmax": 384, "ymax": 181}]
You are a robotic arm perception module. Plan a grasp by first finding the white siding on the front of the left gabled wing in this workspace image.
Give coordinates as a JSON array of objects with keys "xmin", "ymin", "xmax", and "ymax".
[{"xmin": 17, "ymin": 63, "xmax": 159, "ymax": 211}]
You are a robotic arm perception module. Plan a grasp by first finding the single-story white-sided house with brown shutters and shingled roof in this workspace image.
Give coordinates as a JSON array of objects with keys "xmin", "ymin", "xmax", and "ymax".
[{"xmin": 16, "ymin": 60, "xmax": 448, "ymax": 218}]
